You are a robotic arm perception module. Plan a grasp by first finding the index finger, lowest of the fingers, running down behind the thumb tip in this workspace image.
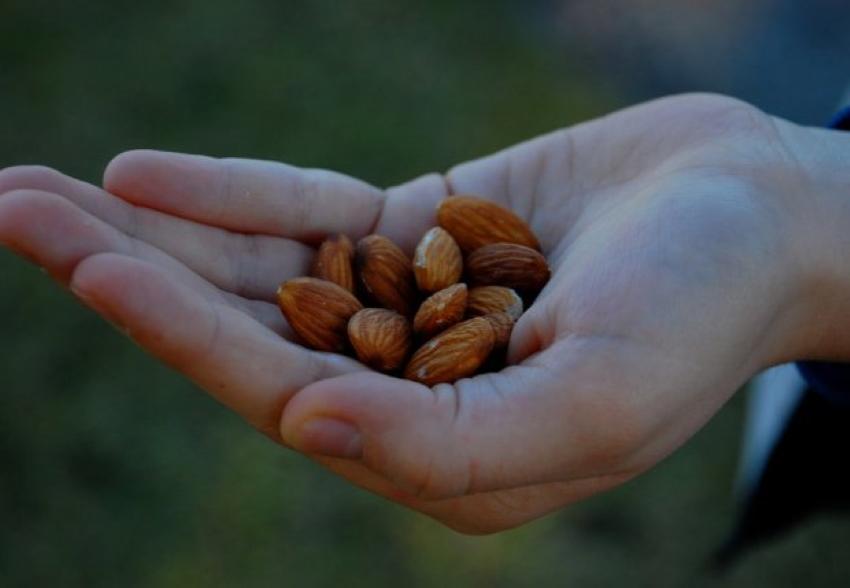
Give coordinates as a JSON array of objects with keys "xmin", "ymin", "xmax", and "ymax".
[{"xmin": 70, "ymin": 253, "xmax": 363, "ymax": 439}]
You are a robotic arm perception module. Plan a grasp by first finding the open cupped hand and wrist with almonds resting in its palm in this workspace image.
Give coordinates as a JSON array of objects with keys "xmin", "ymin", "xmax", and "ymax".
[{"xmin": 0, "ymin": 95, "xmax": 850, "ymax": 533}]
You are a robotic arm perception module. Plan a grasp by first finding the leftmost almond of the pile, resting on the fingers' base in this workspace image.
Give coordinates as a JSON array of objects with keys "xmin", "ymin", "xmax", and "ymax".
[{"xmin": 277, "ymin": 278, "xmax": 363, "ymax": 352}]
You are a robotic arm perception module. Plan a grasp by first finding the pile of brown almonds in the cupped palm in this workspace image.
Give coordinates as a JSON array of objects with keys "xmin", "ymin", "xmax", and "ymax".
[{"xmin": 277, "ymin": 196, "xmax": 550, "ymax": 386}]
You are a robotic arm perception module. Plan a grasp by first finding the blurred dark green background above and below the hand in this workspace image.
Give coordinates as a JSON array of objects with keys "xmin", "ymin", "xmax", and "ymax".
[{"xmin": 0, "ymin": 0, "xmax": 850, "ymax": 588}]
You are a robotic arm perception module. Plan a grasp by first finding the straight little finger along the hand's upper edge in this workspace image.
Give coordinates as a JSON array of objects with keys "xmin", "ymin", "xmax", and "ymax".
[{"xmin": 103, "ymin": 151, "xmax": 384, "ymax": 240}]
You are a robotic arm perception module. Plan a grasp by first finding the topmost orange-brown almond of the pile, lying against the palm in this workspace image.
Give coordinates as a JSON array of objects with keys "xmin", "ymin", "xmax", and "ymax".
[{"xmin": 437, "ymin": 196, "xmax": 540, "ymax": 253}]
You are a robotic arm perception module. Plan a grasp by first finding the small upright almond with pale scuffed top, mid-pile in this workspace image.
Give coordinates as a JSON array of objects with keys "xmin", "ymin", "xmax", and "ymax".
[{"xmin": 413, "ymin": 227, "xmax": 463, "ymax": 293}]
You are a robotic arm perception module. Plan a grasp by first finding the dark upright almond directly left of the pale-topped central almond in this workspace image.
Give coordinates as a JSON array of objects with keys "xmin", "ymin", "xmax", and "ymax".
[{"xmin": 356, "ymin": 235, "xmax": 416, "ymax": 316}]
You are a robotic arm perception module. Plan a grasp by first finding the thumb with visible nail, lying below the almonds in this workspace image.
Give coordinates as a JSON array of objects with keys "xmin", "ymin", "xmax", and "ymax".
[{"xmin": 281, "ymin": 342, "xmax": 638, "ymax": 499}]
